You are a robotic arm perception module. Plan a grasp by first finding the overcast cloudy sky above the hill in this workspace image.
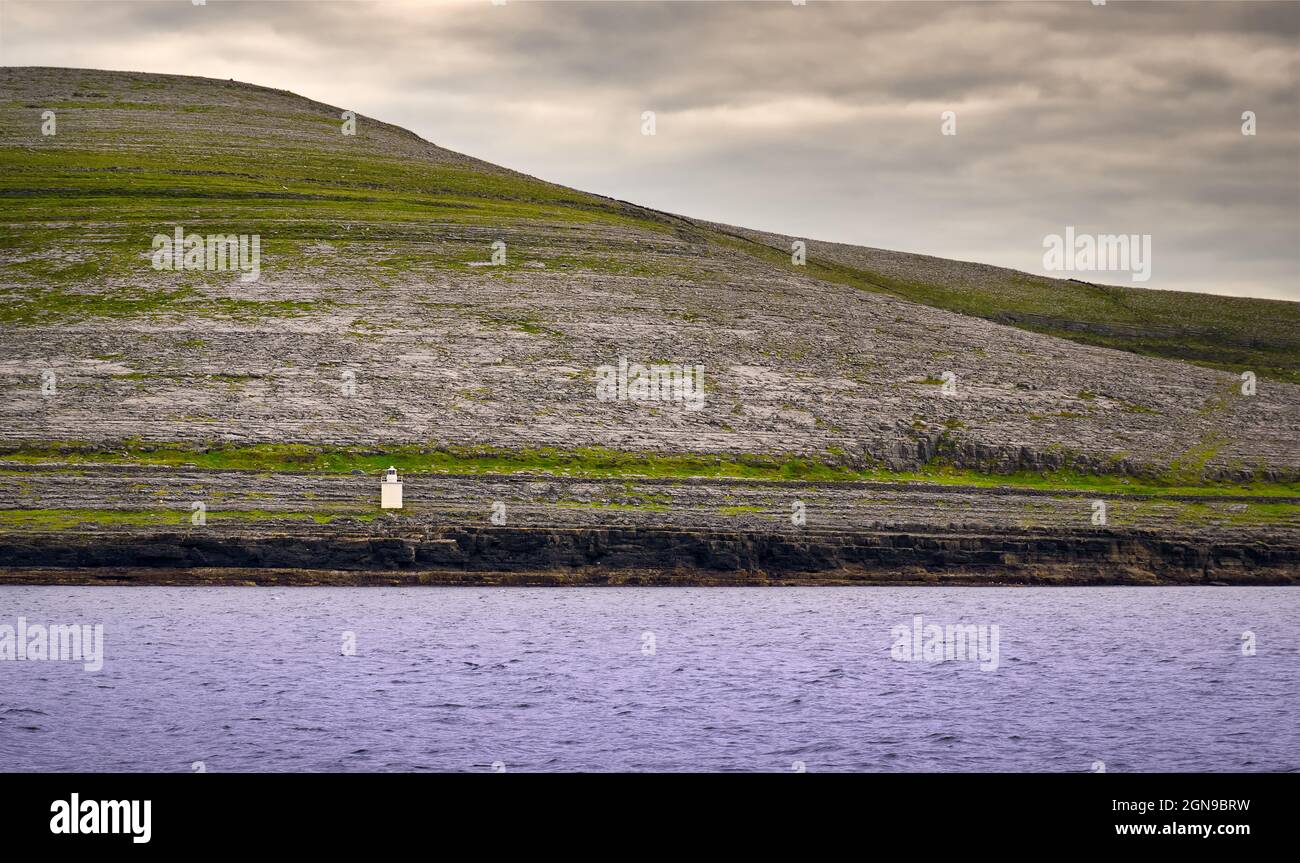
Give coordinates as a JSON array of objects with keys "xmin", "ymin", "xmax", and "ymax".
[{"xmin": 0, "ymin": 0, "xmax": 1300, "ymax": 300}]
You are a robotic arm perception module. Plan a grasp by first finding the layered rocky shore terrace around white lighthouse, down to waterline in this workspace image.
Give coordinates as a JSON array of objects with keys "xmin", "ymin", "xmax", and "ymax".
[{"xmin": 0, "ymin": 467, "xmax": 1300, "ymax": 584}]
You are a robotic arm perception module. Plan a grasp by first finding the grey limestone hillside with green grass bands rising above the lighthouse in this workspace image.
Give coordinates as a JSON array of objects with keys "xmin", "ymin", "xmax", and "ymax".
[{"xmin": 0, "ymin": 69, "xmax": 1300, "ymax": 495}]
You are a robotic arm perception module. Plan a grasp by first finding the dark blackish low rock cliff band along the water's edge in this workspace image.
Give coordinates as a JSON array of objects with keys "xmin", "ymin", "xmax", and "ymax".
[{"xmin": 0, "ymin": 528, "xmax": 1300, "ymax": 584}]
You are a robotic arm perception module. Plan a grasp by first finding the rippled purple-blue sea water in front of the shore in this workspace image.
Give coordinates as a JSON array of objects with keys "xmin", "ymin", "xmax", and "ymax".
[{"xmin": 0, "ymin": 586, "xmax": 1300, "ymax": 772}]
